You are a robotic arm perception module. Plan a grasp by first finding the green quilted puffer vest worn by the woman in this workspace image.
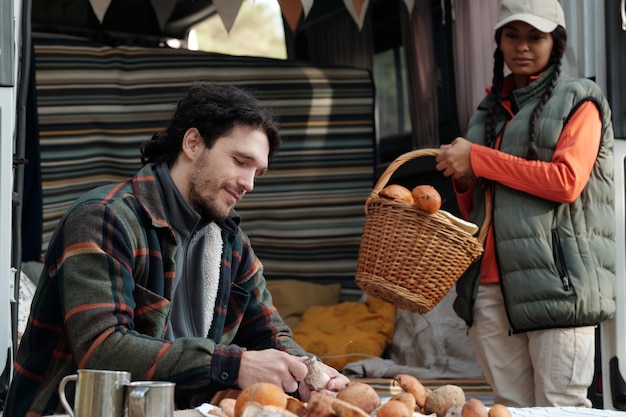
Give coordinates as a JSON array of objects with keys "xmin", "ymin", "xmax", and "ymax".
[{"xmin": 454, "ymin": 68, "xmax": 615, "ymax": 333}]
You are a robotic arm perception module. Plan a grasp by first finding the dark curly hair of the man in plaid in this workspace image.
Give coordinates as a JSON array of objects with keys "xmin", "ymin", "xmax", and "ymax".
[{"xmin": 140, "ymin": 83, "xmax": 280, "ymax": 165}]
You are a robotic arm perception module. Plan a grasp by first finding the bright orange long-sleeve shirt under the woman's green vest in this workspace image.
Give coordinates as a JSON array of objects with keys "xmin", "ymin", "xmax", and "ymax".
[{"xmin": 457, "ymin": 79, "xmax": 602, "ymax": 284}]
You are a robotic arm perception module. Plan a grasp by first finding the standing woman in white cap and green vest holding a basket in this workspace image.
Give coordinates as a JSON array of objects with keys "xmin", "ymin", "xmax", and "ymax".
[{"xmin": 437, "ymin": 0, "xmax": 615, "ymax": 407}]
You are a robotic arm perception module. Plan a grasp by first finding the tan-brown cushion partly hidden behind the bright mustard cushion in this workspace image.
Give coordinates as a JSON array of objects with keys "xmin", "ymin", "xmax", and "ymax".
[{"xmin": 267, "ymin": 279, "xmax": 341, "ymax": 329}]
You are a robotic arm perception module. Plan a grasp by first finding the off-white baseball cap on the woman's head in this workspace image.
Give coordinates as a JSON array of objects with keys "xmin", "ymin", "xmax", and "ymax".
[{"xmin": 493, "ymin": 0, "xmax": 565, "ymax": 33}]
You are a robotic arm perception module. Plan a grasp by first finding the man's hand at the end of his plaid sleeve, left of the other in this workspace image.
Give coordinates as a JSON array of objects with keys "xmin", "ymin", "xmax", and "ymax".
[{"xmin": 237, "ymin": 349, "xmax": 306, "ymax": 393}]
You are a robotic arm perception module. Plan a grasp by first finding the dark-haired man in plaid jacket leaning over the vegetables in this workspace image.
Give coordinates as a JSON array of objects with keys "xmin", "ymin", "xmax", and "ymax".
[{"xmin": 5, "ymin": 83, "xmax": 348, "ymax": 417}]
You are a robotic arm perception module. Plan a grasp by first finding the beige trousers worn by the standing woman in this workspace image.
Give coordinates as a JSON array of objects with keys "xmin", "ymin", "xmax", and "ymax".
[{"xmin": 470, "ymin": 284, "xmax": 595, "ymax": 407}]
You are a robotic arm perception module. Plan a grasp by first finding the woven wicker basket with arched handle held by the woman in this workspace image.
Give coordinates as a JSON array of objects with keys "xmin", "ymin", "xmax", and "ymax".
[{"xmin": 355, "ymin": 149, "xmax": 486, "ymax": 313}]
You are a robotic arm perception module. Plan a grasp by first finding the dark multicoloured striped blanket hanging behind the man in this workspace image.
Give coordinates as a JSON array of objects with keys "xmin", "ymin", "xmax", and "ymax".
[{"xmin": 33, "ymin": 34, "xmax": 375, "ymax": 286}]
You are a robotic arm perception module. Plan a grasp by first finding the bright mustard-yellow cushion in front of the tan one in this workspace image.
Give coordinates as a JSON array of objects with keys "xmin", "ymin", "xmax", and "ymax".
[{"xmin": 293, "ymin": 297, "xmax": 396, "ymax": 370}]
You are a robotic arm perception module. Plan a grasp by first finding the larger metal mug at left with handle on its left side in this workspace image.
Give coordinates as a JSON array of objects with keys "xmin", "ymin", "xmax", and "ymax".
[{"xmin": 59, "ymin": 369, "xmax": 130, "ymax": 417}]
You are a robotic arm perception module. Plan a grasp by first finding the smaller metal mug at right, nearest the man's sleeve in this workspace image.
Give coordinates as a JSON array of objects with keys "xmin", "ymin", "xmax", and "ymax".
[{"xmin": 126, "ymin": 381, "xmax": 176, "ymax": 417}]
